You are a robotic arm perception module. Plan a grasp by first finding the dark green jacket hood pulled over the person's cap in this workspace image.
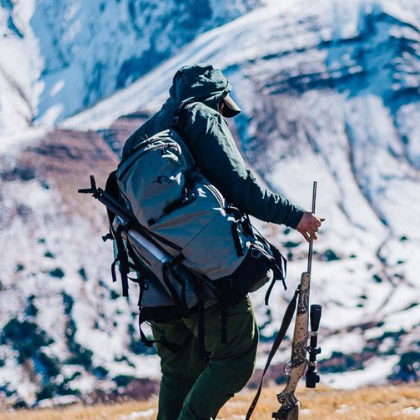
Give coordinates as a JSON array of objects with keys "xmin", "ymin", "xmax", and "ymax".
[{"xmin": 163, "ymin": 64, "xmax": 232, "ymax": 112}]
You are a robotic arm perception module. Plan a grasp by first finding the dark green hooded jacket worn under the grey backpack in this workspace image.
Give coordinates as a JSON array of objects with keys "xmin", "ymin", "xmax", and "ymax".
[{"xmin": 123, "ymin": 64, "xmax": 304, "ymax": 228}]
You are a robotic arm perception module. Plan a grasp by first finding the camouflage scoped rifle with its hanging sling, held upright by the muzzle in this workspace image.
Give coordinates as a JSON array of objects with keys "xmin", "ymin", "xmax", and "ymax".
[{"xmin": 245, "ymin": 182, "xmax": 322, "ymax": 420}]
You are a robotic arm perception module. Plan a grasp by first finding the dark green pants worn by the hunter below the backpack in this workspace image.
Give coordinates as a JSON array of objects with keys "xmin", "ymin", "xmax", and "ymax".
[{"xmin": 152, "ymin": 297, "xmax": 258, "ymax": 420}]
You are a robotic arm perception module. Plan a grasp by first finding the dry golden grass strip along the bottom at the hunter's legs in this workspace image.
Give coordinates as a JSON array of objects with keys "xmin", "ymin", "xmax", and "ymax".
[{"xmin": 0, "ymin": 384, "xmax": 420, "ymax": 420}]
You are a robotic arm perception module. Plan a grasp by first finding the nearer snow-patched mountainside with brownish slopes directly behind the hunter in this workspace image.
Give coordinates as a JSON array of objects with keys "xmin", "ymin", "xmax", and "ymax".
[{"xmin": 0, "ymin": 0, "xmax": 420, "ymax": 402}]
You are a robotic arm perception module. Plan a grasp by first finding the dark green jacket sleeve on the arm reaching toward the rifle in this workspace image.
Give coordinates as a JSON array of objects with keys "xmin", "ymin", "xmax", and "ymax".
[{"xmin": 184, "ymin": 106, "xmax": 304, "ymax": 229}]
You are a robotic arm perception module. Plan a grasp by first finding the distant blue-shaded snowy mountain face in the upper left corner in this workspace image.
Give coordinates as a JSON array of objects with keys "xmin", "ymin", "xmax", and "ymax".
[{"xmin": 0, "ymin": 0, "xmax": 259, "ymax": 131}]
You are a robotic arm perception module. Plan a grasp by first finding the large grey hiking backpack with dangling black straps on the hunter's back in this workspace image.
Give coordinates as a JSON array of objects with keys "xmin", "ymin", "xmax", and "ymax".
[{"xmin": 86, "ymin": 106, "xmax": 286, "ymax": 357}]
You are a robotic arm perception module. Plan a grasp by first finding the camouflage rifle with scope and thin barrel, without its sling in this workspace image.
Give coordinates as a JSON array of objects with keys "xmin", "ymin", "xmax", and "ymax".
[{"xmin": 272, "ymin": 182, "xmax": 321, "ymax": 420}]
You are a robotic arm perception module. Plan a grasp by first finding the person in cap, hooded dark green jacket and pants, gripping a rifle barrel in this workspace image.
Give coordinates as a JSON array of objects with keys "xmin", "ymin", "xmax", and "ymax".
[{"xmin": 123, "ymin": 64, "xmax": 321, "ymax": 420}]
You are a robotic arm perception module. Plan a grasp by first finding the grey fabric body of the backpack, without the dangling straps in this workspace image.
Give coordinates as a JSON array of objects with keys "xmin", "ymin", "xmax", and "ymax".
[{"xmin": 114, "ymin": 126, "xmax": 286, "ymax": 310}]
